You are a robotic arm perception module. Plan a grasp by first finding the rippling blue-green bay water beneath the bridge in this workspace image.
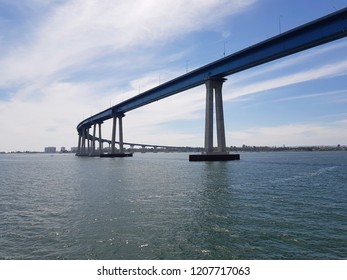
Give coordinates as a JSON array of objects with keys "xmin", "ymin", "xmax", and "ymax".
[{"xmin": 0, "ymin": 152, "xmax": 347, "ymax": 260}]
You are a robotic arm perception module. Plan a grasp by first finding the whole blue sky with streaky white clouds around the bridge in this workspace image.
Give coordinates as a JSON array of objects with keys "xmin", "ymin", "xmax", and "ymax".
[{"xmin": 0, "ymin": 0, "xmax": 347, "ymax": 151}]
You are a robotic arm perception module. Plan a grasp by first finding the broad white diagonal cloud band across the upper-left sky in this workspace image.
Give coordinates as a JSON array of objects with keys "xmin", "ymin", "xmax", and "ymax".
[{"xmin": 0, "ymin": 0, "xmax": 254, "ymax": 86}]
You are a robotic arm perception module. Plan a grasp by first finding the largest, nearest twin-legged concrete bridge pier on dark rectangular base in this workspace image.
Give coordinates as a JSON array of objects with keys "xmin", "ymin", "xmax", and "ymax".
[{"xmin": 189, "ymin": 78, "xmax": 240, "ymax": 161}]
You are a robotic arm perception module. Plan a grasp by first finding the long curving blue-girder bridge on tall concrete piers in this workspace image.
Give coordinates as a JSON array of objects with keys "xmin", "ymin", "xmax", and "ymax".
[{"xmin": 76, "ymin": 8, "xmax": 347, "ymax": 161}]
